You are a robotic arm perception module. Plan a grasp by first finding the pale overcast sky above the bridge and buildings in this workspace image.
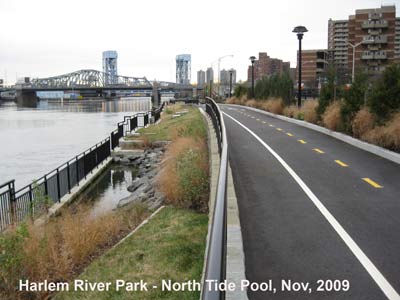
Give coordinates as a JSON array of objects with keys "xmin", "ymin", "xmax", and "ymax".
[{"xmin": 0, "ymin": 0, "xmax": 400, "ymax": 83}]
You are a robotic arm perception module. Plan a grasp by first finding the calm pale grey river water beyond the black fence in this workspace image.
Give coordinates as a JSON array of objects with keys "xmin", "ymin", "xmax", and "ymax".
[{"xmin": 0, "ymin": 97, "xmax": 151, "ymax": 189}]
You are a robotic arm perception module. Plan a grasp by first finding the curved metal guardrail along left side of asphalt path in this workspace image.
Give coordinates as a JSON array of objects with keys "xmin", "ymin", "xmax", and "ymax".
[{"xmin": 201, "ymin": 97, "xmax": 228, "ymax": 300}]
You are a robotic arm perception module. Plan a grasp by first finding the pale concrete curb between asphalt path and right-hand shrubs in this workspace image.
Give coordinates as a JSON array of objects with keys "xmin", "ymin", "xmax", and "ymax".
[{"xmin": 229, "ymin": 104, "xmax": 400, "ymax": 164}]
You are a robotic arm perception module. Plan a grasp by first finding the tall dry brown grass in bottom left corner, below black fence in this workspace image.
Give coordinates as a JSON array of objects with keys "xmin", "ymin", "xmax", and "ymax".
[{"xmin": 0, "ymin": 206, "xmax": 147, "ymax": 299}]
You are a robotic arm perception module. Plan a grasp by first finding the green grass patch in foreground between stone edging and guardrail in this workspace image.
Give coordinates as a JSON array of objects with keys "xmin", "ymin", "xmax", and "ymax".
[{"xmin": 55, "ymin": 207, "xmax": 208, "ymax": 300}]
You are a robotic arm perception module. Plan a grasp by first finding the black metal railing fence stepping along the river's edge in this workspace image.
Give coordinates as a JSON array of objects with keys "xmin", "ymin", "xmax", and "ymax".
[{"xmin": 0, "ymin": 105, "xmax": 164, "ymax": 232}]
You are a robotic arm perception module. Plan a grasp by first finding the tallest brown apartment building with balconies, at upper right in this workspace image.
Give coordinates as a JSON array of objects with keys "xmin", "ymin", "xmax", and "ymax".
[{"xmin": 328, "ymin": 5, "xmax": 400, "ymax": 76}]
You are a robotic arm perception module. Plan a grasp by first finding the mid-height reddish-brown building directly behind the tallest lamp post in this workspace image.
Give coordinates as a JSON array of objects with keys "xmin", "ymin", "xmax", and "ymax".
[{"xmin": 296, "ymin": 49, "xmax": 329, "ymax": 88}]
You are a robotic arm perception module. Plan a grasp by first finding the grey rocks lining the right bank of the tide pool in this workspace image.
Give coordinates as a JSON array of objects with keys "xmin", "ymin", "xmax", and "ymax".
[{"xmin": 112, "ymin": 144, "xmax": 165, "ymax": 210}]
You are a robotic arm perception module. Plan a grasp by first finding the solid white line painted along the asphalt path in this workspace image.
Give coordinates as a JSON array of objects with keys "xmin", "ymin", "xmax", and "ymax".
[{"xmin": 223, "ymin": 112, "xmax": 400, "ymax": 300}]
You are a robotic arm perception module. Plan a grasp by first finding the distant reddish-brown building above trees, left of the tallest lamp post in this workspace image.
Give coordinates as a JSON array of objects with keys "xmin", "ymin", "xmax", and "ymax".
[{"xmin": 247, "ymin": 52, "xmax": 290, "ymax": 82}]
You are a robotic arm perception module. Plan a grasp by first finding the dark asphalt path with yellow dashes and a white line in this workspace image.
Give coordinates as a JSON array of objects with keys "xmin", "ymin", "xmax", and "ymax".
[{"xmin": 221, "ymin": 105, "xmax": 400, "ymax": 300}]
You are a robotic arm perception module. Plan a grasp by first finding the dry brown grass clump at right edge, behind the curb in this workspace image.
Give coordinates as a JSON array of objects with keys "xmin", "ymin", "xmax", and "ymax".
[{"xmin": 361, "ymin": 112, "xmax": 400, "ymax": 152}]
